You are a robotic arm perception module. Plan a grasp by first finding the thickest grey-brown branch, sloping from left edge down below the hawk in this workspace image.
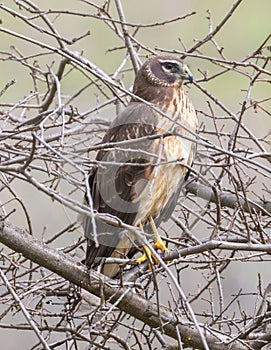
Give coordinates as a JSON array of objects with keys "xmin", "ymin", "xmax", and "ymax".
[{"xmin": 0, "ymin": 224, "xmax": 251, "ymax": 350}]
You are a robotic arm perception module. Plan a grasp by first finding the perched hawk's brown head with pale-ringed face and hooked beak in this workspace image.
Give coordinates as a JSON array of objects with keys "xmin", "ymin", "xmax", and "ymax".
[{"xmin": 139, "ymin": 56, "xmax": 193, "ymax": 87}]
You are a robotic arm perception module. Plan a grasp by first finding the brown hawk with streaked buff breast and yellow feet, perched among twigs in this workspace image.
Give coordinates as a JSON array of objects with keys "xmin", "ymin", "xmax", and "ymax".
[{"xmin": 83, "ymin": 56, "xmax": 197, "ymax": 277}]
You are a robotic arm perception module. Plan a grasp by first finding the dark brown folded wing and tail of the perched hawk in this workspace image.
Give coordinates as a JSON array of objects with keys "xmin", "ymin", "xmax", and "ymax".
[{"xmin": 83, "ymin": 103, "xmax": 158, "ymax": 266}]
